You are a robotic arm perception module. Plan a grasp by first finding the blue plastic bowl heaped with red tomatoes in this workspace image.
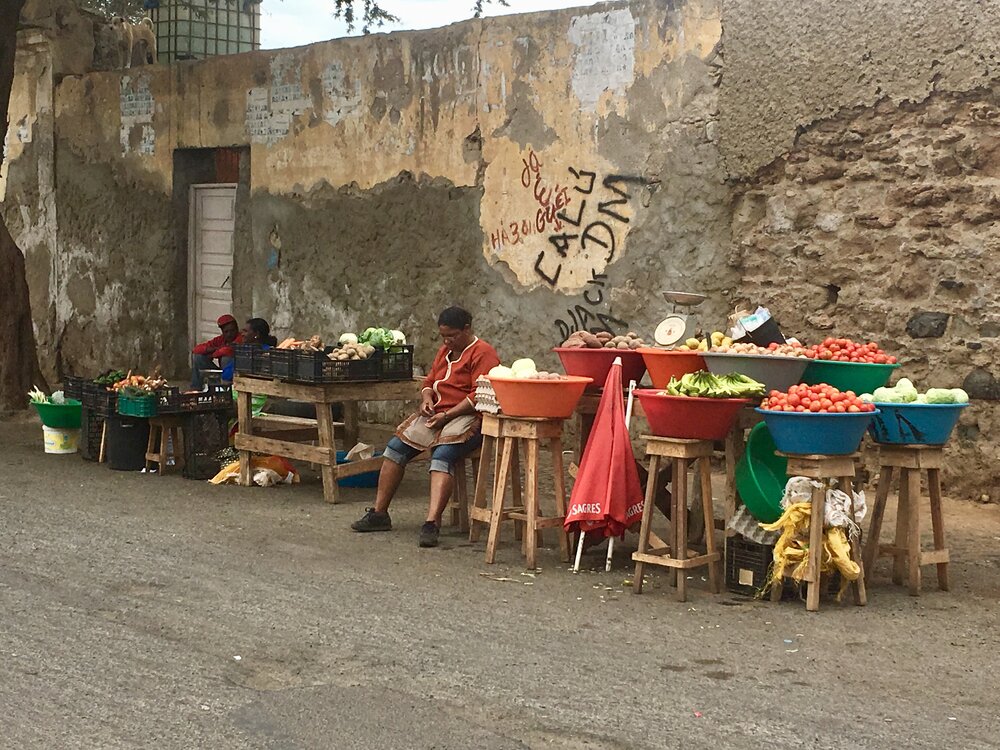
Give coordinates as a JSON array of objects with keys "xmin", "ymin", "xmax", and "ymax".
[{"xmin": 757, "ymin": 409, "xmax": 879, "ymax": 456}]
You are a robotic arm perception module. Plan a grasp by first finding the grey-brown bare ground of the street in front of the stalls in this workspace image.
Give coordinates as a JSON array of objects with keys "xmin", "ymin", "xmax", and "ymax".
[{"xmin": 0, "ymin": 419, "xmax": 1000, "ymax": 750}]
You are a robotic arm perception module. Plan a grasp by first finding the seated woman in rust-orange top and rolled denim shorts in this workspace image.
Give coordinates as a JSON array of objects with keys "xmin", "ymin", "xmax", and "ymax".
[{"xmin": 351, "ymin": 307, "xmax": 500, "ymax": 547}]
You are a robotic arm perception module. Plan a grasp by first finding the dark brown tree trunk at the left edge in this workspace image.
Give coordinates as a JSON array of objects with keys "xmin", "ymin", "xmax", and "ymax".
[{"xmin": 0, "ymin": 0, "xmax": 44, "ymax": 410}]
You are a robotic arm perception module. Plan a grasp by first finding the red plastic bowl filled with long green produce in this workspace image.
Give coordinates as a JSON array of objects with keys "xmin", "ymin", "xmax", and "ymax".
[{"xmin": 635, "ymin": 389, "xmax": 751, "ymax": 440}]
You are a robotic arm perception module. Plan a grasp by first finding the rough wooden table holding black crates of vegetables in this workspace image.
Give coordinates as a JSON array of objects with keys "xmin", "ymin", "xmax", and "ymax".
[{"xmin": 233, "ymin": 375, "xmax": 420, "ymax": 503}]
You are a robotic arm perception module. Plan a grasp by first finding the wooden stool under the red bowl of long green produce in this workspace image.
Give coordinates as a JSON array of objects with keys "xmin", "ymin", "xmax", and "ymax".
[{"xmin": 632, "ymin": 435, "xmax": 722, "ymax": 602}]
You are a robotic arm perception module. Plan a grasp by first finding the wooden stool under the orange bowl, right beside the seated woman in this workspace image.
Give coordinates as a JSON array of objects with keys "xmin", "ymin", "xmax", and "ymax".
[{"xmin": 469, "ymin": 414, "xmax": 569, "ymax": 569}]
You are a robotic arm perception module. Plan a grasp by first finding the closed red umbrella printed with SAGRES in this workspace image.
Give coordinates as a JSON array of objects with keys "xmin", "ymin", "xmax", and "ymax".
[{"xmin": 564, "ymin": 358, "xmax": 643, "ymax": 568}]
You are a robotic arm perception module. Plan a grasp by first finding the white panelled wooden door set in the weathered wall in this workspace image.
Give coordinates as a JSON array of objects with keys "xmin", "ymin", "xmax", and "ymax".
[{"xmin": 188, "ymin": 185, "xmax": 236, "ymax": 344}]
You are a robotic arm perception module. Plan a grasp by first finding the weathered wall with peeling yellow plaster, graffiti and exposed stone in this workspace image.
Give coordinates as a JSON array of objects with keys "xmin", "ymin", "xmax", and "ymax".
[{"xmin": 4, "ymin": 0, "xmax": 1000, "ymax": 500}]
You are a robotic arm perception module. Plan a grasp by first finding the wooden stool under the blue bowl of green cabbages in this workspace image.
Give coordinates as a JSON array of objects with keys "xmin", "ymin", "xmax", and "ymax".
[{"xmin": 865, "ymin": 445, "xmax": 949, "ymax": 596}]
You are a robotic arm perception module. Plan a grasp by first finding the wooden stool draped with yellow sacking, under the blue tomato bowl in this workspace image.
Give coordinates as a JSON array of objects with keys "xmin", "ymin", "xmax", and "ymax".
[{"xmin": 771, "ymin": 453, "xmax": 868, "ymax": 612}]
